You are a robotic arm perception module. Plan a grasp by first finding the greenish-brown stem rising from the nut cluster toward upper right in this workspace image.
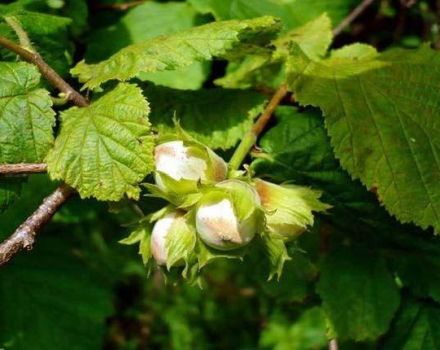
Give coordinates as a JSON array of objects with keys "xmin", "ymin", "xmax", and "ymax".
[{"xmin": 229, "ymin": 84, "xmax": 288, "ymax": 171}]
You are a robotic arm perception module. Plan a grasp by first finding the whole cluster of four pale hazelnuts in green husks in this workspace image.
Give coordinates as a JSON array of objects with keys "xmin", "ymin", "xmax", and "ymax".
[{"xmin": 148, "ymin": 137, "xmax": 328, "ymax": 267}]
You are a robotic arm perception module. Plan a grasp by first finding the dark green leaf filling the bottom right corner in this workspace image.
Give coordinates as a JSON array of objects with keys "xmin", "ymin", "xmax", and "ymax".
[{"xmin": 382, "ymin": 298, "xmax": 440, "ymax": 350}]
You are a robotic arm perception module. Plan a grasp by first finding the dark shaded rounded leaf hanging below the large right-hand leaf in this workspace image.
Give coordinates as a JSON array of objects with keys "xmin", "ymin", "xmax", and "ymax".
[{"xmin": 317, "ymin": 247, "xmax": 400, "ymax": 341}]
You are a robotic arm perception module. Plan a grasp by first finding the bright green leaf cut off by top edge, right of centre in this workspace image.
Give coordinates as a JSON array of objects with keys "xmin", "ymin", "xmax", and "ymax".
[{"xmin": 189, "ymin": 0, "xmax": 358, "ymax": 30}]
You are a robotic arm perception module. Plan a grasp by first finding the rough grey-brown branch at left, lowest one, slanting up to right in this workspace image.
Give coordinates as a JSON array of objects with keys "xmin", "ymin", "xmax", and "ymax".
[{"xmin": 0, "ymin": 184, "xmax": 75, "ymax": 266}]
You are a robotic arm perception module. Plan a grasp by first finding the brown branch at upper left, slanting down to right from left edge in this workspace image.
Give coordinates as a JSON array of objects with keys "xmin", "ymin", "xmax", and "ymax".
[{"xmin": 0, "ymin": 36, "xmax": 89, "ymax": 107}]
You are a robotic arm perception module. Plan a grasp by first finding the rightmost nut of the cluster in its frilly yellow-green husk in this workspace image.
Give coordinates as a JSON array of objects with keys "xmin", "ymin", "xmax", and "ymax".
[{"xmin": 255, "ymin": 179, "xmax": 330, "ymax": 240}]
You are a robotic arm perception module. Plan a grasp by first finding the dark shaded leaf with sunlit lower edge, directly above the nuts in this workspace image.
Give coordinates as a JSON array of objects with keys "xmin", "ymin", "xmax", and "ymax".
[{"xmin": 144, "ymin": 86, "xmax": 266, "ymax": 149}]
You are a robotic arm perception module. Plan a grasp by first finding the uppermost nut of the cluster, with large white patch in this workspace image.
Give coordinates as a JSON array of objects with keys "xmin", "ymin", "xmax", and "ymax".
[{"xmin": 154, "ymin": 140, "xmax": 227, "ymax": 194}]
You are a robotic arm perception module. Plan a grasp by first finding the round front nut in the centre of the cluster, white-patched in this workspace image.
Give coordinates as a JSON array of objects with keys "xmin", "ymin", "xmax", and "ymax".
[{"xmin": 196, "ymin": 180, "xmax": 262, "ymax": 250}]
